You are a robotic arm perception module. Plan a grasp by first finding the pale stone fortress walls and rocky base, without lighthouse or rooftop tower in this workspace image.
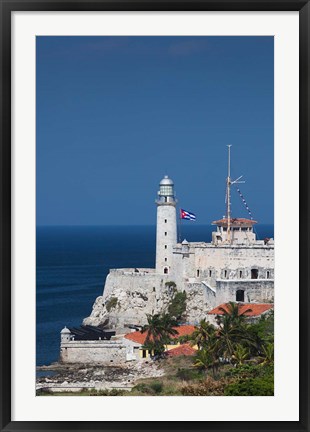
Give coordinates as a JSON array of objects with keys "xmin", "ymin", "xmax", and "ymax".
[{"xmin": 83, "ymin": 243, "xmax": 274, "ymax": 328}]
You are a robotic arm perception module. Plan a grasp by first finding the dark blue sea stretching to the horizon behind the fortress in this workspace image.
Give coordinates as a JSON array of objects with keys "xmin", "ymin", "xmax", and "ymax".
[{"xmin": 36, "ymin": 222, "xmax": 273, "ymax": 365}]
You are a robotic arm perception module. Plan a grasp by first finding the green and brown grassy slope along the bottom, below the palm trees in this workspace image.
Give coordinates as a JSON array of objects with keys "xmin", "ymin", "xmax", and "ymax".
[{"xmin": 39, "ymin": 356, "xmax": 273, "ymax": 396}]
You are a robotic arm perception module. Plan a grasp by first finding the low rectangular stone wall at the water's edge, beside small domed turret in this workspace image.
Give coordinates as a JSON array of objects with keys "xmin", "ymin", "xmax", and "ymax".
[{"xmin": 60, "ymin": 340, "xmax": 126, "ymax": 366}]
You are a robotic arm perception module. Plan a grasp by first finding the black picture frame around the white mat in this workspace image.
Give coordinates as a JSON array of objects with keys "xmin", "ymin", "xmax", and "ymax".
[{"xmin": 0, "ymin": 0, "xmax": 310, "ymax": 432}]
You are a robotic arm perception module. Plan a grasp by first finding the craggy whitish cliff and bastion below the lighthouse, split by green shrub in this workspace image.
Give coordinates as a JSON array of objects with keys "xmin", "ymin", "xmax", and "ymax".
[{"xmin": 83, "ymin": 269, "xmax": 213, "ymax": 332}]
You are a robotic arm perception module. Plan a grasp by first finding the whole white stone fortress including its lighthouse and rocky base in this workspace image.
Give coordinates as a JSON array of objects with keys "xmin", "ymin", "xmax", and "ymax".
[{"xmin": 83, "ymin": 176, "xmax": 274, "ymax": 328}]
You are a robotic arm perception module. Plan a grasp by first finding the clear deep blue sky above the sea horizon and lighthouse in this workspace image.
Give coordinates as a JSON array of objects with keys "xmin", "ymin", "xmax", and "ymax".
[{"xmin": 36, "ymin": 36, "xmax": 274, "ymax": 225}]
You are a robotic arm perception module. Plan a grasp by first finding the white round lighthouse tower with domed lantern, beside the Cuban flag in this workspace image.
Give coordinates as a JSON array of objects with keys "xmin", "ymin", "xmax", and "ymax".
[{"xmin": 156, "ymin": 176, "xmax": 177, "ymax": 274}]
